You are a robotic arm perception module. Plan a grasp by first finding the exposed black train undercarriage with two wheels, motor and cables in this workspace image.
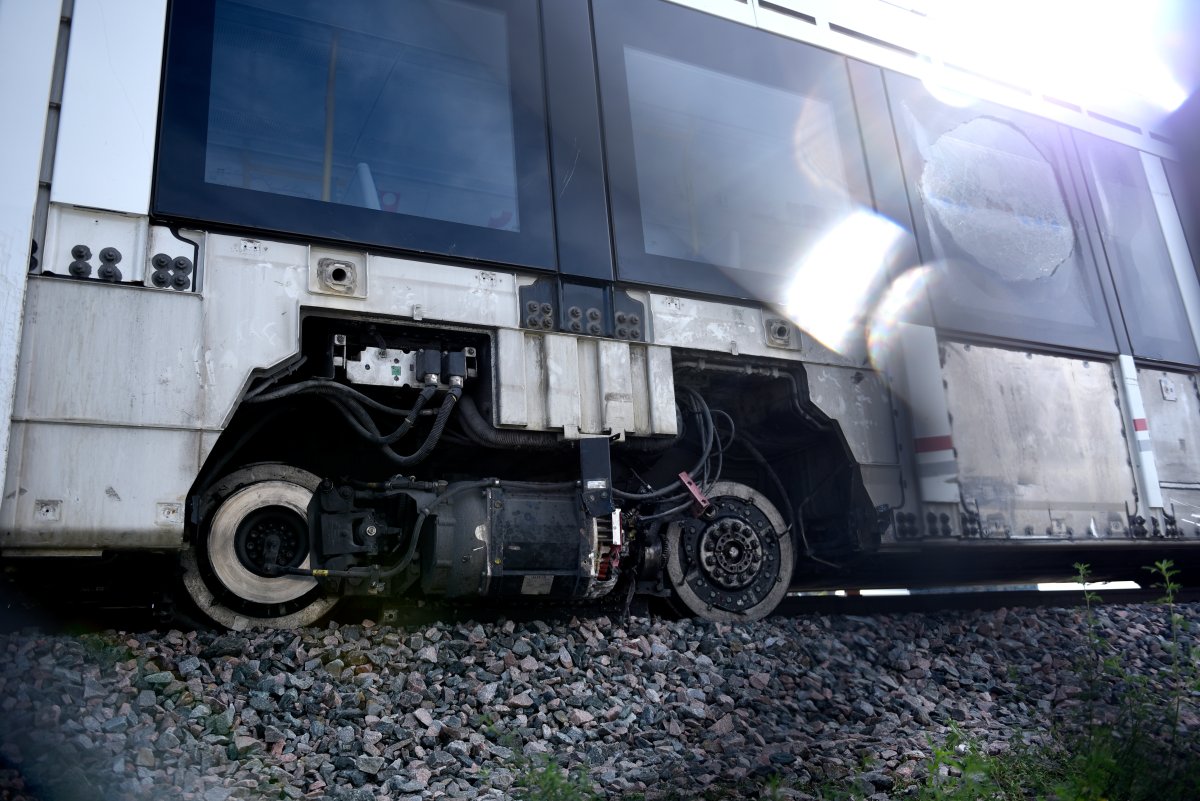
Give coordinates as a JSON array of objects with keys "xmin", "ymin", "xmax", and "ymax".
[{"xmin": 182, "ymin": 318, "xmax": 887, "ymax": 628}]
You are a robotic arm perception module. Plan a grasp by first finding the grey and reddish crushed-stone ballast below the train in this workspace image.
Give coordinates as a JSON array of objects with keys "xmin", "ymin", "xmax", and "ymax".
[{"xmin": 0, "ymin": 606, "xmax": 1200, "ymax": 801}]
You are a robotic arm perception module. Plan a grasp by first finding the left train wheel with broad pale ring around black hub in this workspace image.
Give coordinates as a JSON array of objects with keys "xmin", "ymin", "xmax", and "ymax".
[{"xmin": 182, "ymin": 464, "xmax": 337, "ymax": 631}]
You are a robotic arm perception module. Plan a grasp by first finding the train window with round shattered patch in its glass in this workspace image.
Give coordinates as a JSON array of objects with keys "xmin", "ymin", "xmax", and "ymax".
[{"xmin": 887, "ymin": 73, "xmax": 1116, "ymax": 351}]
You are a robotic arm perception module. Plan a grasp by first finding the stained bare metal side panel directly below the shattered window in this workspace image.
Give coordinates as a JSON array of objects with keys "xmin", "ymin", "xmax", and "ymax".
[{"xmin": 942, "ymin": 342, "xmax": 1135, "ymax": 538}]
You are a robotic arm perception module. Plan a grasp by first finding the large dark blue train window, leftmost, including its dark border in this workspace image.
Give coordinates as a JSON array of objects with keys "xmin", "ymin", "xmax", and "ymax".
[{"xmin": 155, "ymin": 0, "xmax": 554, "ymax": 267}]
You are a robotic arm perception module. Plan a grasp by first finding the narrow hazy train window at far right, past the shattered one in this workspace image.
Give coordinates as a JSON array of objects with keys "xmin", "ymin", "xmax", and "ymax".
[{"xmin": 1075, "ymin": 132, "xmax": 1196, "ymax": 365}]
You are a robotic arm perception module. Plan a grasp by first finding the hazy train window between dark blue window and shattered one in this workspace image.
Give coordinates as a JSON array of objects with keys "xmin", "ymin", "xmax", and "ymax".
[{"xmin": 594, "ymin": 0, "xmax": 870, "ymax": 300}]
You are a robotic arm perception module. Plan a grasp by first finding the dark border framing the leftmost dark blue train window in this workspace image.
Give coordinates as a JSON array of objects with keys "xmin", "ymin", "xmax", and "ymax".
[{"xmin": 150, "ymin": 0, "xmax": 557, "ymax": 270}]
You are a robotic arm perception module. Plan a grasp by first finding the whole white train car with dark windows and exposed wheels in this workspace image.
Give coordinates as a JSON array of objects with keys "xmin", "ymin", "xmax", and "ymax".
[{"xmin": 0, "ymin": 0, "xmax": 1200, "ymax": 628}]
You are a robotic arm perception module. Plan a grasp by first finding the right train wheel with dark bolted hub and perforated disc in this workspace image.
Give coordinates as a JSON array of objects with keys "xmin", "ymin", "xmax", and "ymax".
[{"xmin": 665, "ymin": 481, "xmax": 794, "ymax": 622}]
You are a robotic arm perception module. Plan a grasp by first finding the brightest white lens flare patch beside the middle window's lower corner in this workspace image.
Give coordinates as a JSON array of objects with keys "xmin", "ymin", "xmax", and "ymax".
[{"xmin": 786, "ymin": 209, "xmax": 910, "ymax": 353}]
